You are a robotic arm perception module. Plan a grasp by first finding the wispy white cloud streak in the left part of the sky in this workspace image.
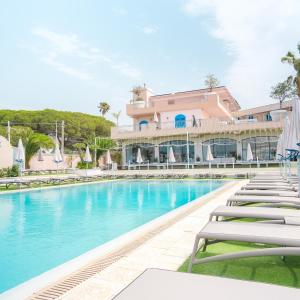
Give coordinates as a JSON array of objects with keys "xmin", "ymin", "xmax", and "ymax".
[{"xmin": 26, "ymin": 28, "xmax": 141, "ymax": 80}]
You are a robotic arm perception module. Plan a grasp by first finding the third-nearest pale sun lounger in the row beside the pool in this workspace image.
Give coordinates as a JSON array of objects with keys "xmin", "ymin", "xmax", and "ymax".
[{"xmin": 210, "ymin": 205, "xmax": 300, "ymax": 225}]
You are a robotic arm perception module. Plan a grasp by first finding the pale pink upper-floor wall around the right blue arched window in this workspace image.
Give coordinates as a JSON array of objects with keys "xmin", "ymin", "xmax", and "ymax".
[{"xmin": 160, "ymin": 109, "xmax": 204, "ymax": 128}]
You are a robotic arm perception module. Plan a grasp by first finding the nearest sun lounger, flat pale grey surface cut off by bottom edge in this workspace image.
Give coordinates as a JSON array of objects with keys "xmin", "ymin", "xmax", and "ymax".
[{"xmin": 113, "ymin": 269, "xmax": 300, "ymax": 300}]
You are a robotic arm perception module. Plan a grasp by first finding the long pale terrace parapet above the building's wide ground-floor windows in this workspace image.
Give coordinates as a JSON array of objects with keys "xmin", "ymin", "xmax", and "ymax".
[{"xmin": 111, "ymin": 119, "xmax": 283, "ymax": 139}]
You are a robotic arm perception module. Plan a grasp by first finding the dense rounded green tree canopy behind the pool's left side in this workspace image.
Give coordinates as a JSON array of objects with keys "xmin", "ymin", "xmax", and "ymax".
[{"xmin": 0, "ymin": 109, "xmax": 114, "ymax": 149}]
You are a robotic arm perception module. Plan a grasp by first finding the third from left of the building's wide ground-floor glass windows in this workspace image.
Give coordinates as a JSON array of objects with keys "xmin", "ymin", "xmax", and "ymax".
[{"xmin": 202, "ymin": 138, "xmax": 237, "ymax": 160}]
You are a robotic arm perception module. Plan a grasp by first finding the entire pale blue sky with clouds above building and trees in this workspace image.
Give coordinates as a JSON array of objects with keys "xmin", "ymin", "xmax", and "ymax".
[{"xmin": 0, "ymin": 0, "xmax": 300, "ymax": 123}]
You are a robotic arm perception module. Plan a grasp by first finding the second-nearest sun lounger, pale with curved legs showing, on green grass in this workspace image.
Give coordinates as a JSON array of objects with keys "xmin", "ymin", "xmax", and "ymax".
[{"xmin": 189, "ymin": 221, "xmax": 300, "ymax": 272}]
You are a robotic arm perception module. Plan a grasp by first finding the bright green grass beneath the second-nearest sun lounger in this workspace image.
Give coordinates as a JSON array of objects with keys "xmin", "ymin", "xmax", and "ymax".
[{"xmin": 178, "ymin": 242, "xmax": 300, "ymax": 288}]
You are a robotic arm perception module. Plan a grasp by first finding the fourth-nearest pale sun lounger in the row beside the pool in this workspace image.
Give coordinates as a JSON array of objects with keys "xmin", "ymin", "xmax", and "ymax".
[{"xmin": 226, "ymin": 195, "xmax": 300, "ymax": 208}]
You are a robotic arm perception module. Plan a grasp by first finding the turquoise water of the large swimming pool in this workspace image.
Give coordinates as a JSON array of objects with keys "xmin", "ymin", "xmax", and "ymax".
[{"xmin": 0, "ymin": 180, "xmax": 222, "ymax": 292}]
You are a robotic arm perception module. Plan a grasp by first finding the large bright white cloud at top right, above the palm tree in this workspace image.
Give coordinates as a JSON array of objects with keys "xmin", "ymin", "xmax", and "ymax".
[{"xmin": 184, "ymin": 0, "xmax": 300, "ymax": 107}]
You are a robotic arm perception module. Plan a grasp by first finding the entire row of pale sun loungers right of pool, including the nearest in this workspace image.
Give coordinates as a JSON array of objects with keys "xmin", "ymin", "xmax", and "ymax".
[{"xmin": 114, "ymin": 170, "xmax": 300, "ymax": 300}]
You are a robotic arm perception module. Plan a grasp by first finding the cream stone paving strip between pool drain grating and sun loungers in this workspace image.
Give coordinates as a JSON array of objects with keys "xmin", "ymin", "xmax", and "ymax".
[{"xmin": 53, "ymin": 180, "xmax": 248, "ymax": 300}]
